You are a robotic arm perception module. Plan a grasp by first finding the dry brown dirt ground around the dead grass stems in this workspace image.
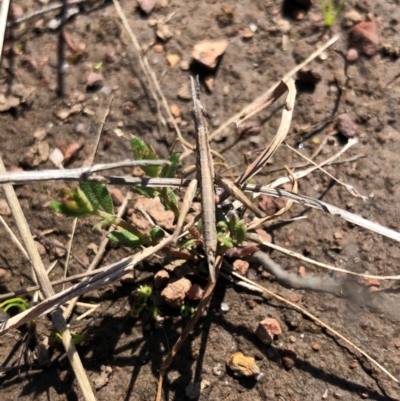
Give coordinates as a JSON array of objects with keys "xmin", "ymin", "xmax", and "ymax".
[{"xmin": 0, "ymin": 0, "xmax": 400, "ymax": 401}]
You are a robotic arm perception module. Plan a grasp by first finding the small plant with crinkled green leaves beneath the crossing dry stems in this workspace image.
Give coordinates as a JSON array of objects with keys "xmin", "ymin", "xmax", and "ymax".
[{"xmin": 50, "ymin": 138, "xmax": 246, "ymax": 270}]
